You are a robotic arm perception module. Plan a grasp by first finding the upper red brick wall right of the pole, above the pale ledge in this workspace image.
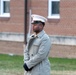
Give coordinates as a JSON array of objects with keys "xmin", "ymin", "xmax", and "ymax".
[{"xmin": 32, "ymin": 0, "xmax": 76, "ymax": 36}]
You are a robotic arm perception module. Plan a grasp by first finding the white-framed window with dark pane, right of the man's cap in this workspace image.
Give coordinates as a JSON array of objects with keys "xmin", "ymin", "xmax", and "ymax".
[{"xmin": 48, "ymin": 0, "xmax": 60, "ymax": 19}]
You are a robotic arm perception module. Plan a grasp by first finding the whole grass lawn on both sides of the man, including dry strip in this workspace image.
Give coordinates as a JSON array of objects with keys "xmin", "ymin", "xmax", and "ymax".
[{"xmin": 0, "ymin": 54, "xmax": 76, "ymax": 75}]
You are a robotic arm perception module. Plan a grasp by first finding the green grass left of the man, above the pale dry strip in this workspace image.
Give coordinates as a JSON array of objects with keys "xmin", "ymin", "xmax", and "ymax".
[{"xmin": 0, "ymin": 54, "xmax": 23, "ymax": 69}]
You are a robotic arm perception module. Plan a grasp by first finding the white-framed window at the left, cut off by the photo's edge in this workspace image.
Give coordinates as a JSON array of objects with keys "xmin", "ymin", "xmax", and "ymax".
[{"xmin": 0, "ymin": 0, "xmax": 10, "ymax": 17}]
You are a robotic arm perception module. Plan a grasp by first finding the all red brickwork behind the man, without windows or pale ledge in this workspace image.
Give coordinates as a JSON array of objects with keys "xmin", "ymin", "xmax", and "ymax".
[{"xmin": 0, "ymin": 0, "xmax": 76, "ymax": 58}]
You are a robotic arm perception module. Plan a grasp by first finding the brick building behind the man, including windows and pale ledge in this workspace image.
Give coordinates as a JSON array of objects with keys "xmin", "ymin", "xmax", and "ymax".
[{"xmin": 0, "ymin": 0, "xmax": 76, "ymax": 58}]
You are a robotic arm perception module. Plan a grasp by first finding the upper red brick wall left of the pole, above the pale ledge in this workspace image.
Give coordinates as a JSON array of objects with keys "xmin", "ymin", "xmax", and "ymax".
[{"xmin": 0, "ymin": 0, "xmax": 24, "ymax": 33}]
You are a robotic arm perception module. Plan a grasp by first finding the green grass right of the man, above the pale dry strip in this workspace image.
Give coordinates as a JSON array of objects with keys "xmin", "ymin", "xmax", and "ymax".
[{"xmin": 49, "ymin": 58, "xmax": 76, "ymax": 71}]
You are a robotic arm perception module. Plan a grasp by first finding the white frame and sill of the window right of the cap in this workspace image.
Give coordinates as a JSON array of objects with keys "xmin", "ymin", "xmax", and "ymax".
[{"xmin": 48, "ymin": 0, "xmax": 60, "ymax": 19}]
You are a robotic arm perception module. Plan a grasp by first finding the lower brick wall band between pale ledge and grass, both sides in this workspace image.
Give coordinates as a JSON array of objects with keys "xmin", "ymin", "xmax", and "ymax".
[{"xmin": 0, "ymin": 41, "xmax": 76, "ymax": 58}]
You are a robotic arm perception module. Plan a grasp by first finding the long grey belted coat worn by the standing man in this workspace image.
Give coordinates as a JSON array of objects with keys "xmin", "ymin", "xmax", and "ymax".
[{"xmin": 24, "ymin": 30, "xmax": 51, "ymax": 75}]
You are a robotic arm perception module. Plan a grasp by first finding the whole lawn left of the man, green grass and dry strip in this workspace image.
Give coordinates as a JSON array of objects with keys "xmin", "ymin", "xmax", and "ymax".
[{"xmin": 0, "ymin": 54, "xmax": 24, "ymax": 75}]
